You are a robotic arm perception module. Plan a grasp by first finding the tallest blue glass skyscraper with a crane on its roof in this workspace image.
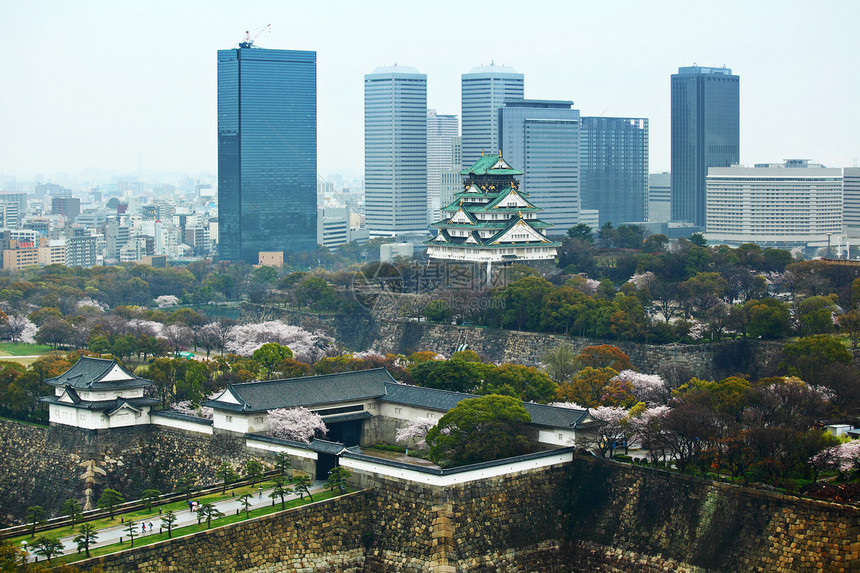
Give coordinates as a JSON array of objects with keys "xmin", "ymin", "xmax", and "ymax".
[{"xmin": 218, "ymin": 42, "xmax": 317, "ymax": 263}]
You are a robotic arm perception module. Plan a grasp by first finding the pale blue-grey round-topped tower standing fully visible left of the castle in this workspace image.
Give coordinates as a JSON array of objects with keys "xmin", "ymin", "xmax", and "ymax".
[{"xmin": 364, "ymin": 66, "xmax": 428, "ymax": 236}]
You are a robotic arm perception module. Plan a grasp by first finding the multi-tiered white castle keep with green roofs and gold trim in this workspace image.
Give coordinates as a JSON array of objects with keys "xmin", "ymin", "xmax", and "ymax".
[{"xmin": 427, "ymin": 152, "xmax": 561, "ymax": 274}]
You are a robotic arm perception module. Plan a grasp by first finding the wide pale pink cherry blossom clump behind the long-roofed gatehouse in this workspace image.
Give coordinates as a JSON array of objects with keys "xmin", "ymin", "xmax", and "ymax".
[{"xmin": 225, "ymin": 320, "xmax": 334, "ymax": 364}]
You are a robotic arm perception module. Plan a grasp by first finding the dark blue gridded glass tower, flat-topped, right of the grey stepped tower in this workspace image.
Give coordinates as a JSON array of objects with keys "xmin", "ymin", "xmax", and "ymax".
[{"xmin": 579, "ymin": 117, "xmax": 648, "ymax": 227}]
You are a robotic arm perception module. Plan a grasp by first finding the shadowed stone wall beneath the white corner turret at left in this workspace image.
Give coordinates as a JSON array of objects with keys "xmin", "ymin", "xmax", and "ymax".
[{"xmin": 0, "ymin": 420, "xmax": 258, "ymax": 523}]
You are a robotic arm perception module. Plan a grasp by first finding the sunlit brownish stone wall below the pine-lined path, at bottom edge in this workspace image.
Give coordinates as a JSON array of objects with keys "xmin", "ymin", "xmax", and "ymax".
[{"xmin": 76, "ymin": 491, "xmax": 373, "ymax": 573}]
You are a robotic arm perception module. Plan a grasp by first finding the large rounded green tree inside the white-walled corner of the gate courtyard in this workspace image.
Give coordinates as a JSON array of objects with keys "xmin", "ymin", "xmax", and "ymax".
[{"xmin": 427, "ymin": 395, "xmax": 531, "ymax": 466}]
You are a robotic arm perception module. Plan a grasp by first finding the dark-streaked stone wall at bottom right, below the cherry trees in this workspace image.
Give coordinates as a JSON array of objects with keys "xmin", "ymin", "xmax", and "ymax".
[{"xmin": 566, "ymin": 457, "xmax": 860, "ymax": 573}]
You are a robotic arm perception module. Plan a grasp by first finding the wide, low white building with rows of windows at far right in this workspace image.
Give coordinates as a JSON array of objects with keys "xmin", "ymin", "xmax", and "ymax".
[{"xmin": 705, "ymin": 159, "xmax": 842, "ymax": 255}]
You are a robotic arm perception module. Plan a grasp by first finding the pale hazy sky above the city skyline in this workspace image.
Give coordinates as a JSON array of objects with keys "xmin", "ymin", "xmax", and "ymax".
[{"xmin": 0, "ymin": 0, "xmax": 860, "ymax": 178}]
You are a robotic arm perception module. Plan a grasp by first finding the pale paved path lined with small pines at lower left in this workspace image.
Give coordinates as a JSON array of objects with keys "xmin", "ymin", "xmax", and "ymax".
[{"xmin": 24, "ymin": 481, "xmax": 325, "ymax": 561}]
